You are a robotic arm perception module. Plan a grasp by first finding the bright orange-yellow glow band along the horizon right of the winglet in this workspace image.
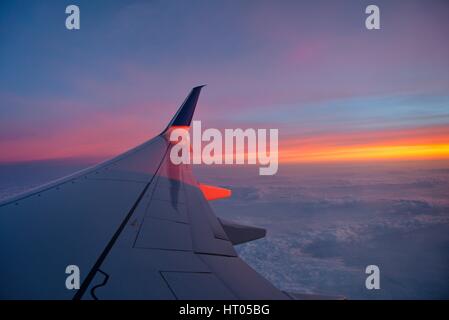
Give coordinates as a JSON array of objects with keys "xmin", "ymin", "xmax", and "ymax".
[{"xmin": 279, "ymin": 127, "xmax": 449, "ymax": 163}]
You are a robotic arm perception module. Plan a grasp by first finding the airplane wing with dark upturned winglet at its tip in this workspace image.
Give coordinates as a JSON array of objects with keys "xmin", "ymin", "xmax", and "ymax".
[{"xmin": 0, "ymin": 87, "xmax": 292, "ymax": 299}]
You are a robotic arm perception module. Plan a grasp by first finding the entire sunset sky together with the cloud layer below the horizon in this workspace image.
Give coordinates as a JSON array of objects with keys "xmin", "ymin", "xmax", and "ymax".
[{"xmin": 0, "ymin": 0, "xmax": 449, "ymax": 299}]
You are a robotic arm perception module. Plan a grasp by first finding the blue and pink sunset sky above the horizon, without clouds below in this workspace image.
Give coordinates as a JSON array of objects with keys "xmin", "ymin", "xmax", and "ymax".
[{"xmin": 0, "ymin": 0, "xmax": 449, "ymax": 163}]
